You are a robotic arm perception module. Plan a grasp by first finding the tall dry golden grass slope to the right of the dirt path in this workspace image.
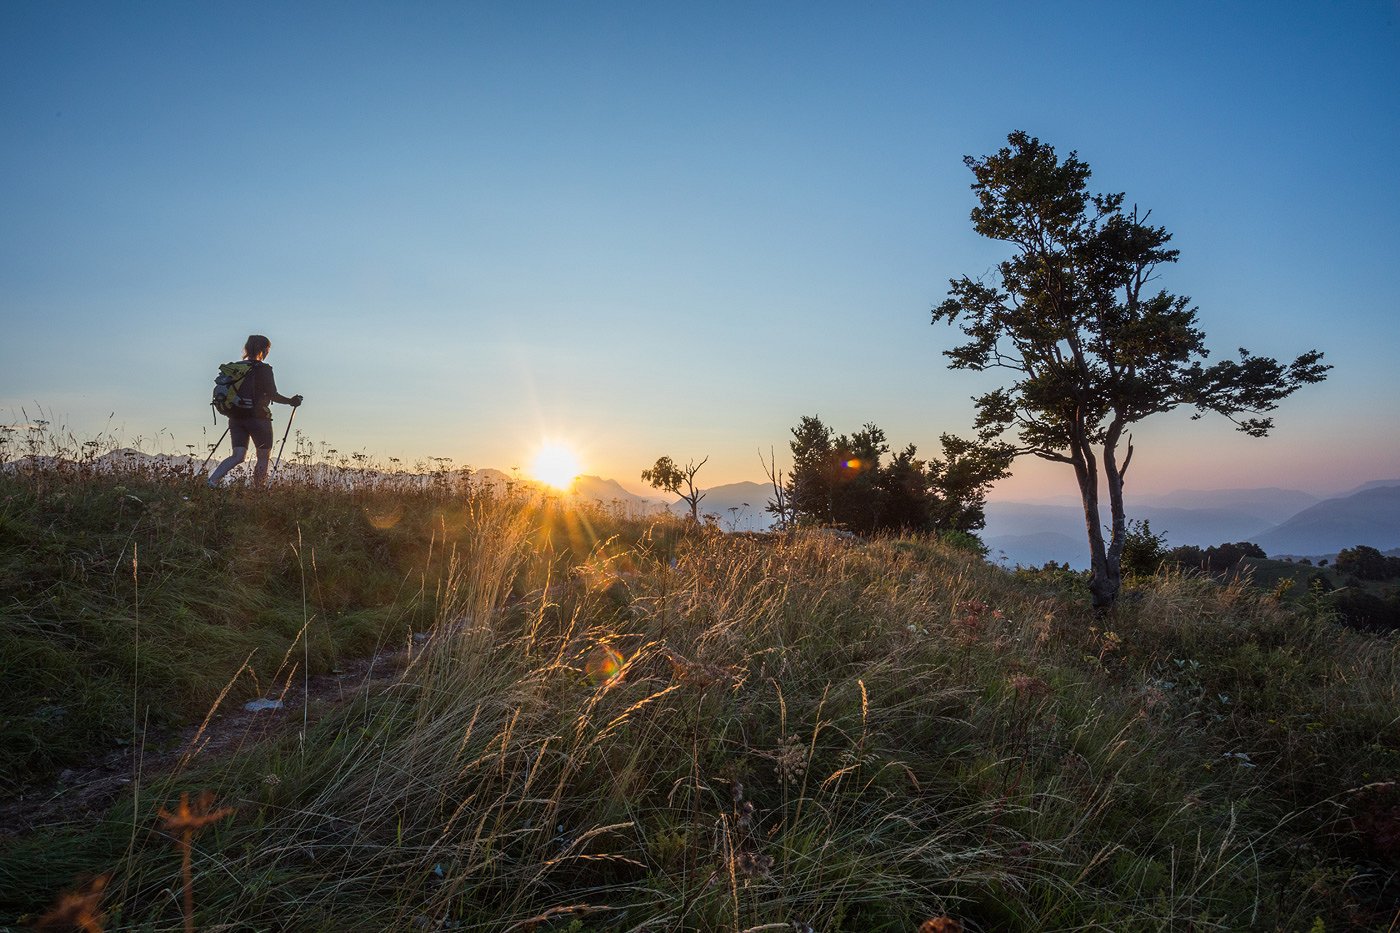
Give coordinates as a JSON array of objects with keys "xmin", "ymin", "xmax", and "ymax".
[{"xmin": 0, "ymin": 439, "xmax": 1400, "ymax": 932}]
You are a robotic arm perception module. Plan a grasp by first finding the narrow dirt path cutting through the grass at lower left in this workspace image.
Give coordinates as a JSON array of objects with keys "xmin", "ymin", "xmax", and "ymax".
[{"xmin": 0, "ymin": 639, "xmax": 420, "ymax": 842}]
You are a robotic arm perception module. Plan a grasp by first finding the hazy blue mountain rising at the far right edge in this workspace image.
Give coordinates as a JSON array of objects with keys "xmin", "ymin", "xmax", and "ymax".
[{"xmin": 1252, "ymin": 485, "xmax": 1400, "ymax": 553}]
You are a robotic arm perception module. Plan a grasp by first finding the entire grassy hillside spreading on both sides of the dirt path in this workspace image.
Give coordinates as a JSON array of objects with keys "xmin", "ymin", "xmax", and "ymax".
[{"xmin": 0, "ymin": 462, "xmax": 1400, "ymax": 930}]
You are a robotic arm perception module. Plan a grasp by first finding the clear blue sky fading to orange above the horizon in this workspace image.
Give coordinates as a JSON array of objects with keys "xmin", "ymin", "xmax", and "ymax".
[{"xmin": 0, "ymin": 0, "xmax": 1400, "ymax": 497}]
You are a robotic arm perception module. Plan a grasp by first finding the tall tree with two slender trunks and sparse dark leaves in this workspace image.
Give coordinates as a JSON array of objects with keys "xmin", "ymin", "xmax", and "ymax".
[{"xmin": 932, "ymin": 132, "xmax": 1331, "ymax": 607}]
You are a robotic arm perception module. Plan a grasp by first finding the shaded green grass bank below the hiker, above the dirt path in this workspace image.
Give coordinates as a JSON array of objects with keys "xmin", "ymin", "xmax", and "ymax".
[{"xmin": 0, "ymin": 469, "xmax": 506, "ymax": 790}]
